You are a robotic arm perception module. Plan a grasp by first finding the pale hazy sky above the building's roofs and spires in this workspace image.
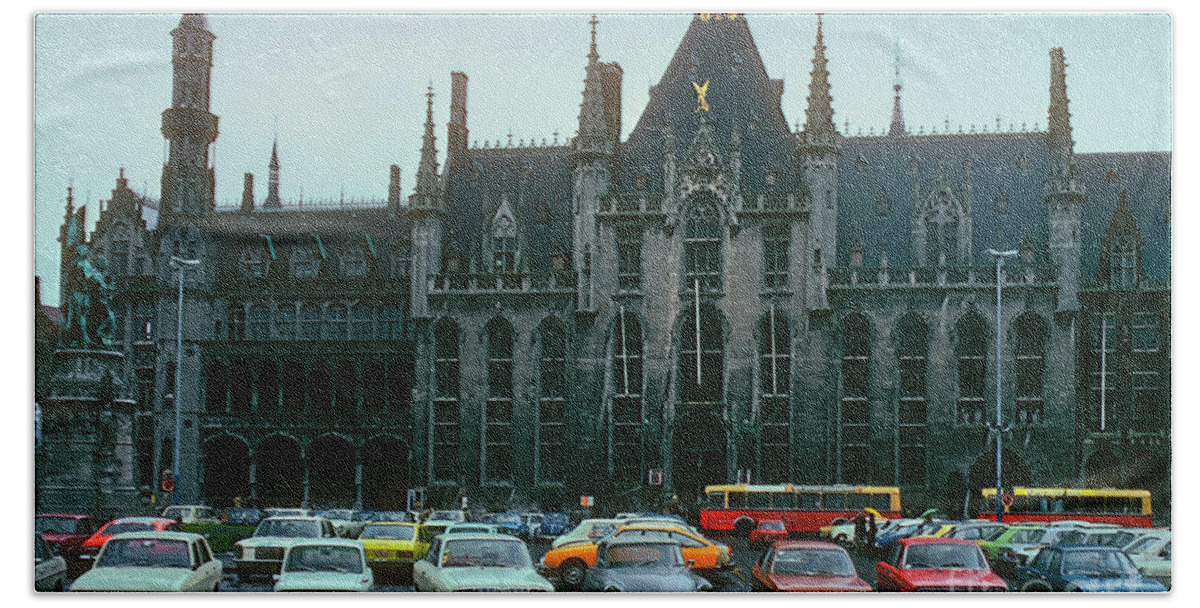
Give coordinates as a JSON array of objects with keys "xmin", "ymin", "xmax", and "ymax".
[{"xmin": 34, "ymin": 7, "xmax": 1171, "ymax": 297}]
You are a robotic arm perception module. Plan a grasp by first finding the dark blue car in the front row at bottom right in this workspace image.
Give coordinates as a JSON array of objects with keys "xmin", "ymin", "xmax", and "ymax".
[{"xmin": 1009, "ymin": 544, "xmax": 1166, "ymax": 591}]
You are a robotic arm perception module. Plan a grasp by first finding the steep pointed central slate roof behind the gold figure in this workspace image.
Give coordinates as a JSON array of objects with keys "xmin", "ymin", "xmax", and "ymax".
[{"xmin": 613, "ymin": 14, "xmax": 800, "ymax": 194}]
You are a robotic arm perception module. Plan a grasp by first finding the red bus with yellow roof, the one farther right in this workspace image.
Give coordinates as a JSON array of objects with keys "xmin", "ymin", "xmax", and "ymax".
[{"xmin": 979, "ymin": 486, "xmax": 1152, "ymax": 528}]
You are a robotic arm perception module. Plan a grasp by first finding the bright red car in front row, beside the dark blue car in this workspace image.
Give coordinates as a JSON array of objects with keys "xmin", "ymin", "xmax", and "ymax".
[{"xmin": 875, "ymin": 536, "xmax": 1008, "ymax": 591}]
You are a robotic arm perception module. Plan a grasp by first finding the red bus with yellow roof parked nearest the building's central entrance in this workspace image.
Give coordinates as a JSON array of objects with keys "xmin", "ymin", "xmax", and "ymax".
[{"xmin": 700, "ymin": 484, "xmax": 900, "ymax": 536}]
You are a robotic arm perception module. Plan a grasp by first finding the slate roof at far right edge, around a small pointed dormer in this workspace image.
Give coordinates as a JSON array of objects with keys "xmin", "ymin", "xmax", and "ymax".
[{"xmin": 1075, "ymin": 152, "xmax": 1171, "ymax": 283}]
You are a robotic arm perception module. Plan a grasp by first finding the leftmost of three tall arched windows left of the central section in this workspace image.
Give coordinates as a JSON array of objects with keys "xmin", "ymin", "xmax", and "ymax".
[{"xmin": 431, "ymin": 319, "xmax": 458, "ymax": 480}]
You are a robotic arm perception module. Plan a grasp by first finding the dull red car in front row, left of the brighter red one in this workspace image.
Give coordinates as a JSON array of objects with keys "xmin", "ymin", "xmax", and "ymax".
[{"xmin": 750, "ymin": 541, "xmax": 871, "ymax": 591}]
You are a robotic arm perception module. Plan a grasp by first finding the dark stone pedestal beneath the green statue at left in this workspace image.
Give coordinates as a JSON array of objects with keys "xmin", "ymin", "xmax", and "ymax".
[{"xmin": 35, "ymin": 348, "xmax": 144, "ymax": 517}]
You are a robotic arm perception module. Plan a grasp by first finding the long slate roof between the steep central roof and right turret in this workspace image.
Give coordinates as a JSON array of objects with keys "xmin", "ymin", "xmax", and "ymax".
[{"xmin": 838, "ymin": 132, "xmax": 1051, "ymax": 267}]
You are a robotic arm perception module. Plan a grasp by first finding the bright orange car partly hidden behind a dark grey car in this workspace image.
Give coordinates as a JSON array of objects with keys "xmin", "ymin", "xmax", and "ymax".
[{"xmin": 541, "ymin": 524, "xmax": 733, "ymax": 589}]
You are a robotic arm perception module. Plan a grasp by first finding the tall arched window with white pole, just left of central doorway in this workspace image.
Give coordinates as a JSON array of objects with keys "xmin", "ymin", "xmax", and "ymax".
[{"xmin": 610, "ymin": 311, "xmax": 644, "ymax": 482}]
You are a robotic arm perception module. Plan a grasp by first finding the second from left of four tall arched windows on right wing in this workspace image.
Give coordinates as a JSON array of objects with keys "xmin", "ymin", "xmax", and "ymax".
[{"xmin": 896, "ymin": 313, "xmax": 929, "ymax": 486}]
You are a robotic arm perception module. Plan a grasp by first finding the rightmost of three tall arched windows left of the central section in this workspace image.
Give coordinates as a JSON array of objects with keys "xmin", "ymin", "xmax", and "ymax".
[{"xmin": 538, "ymin": 318, "xmax": 566, "ymax": 482}]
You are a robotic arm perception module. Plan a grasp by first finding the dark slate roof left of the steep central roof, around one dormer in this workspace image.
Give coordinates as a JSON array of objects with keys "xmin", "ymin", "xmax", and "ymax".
[{"xmin": 444, "ymin": 146, "xmax": 574, "ymax": 272}]
